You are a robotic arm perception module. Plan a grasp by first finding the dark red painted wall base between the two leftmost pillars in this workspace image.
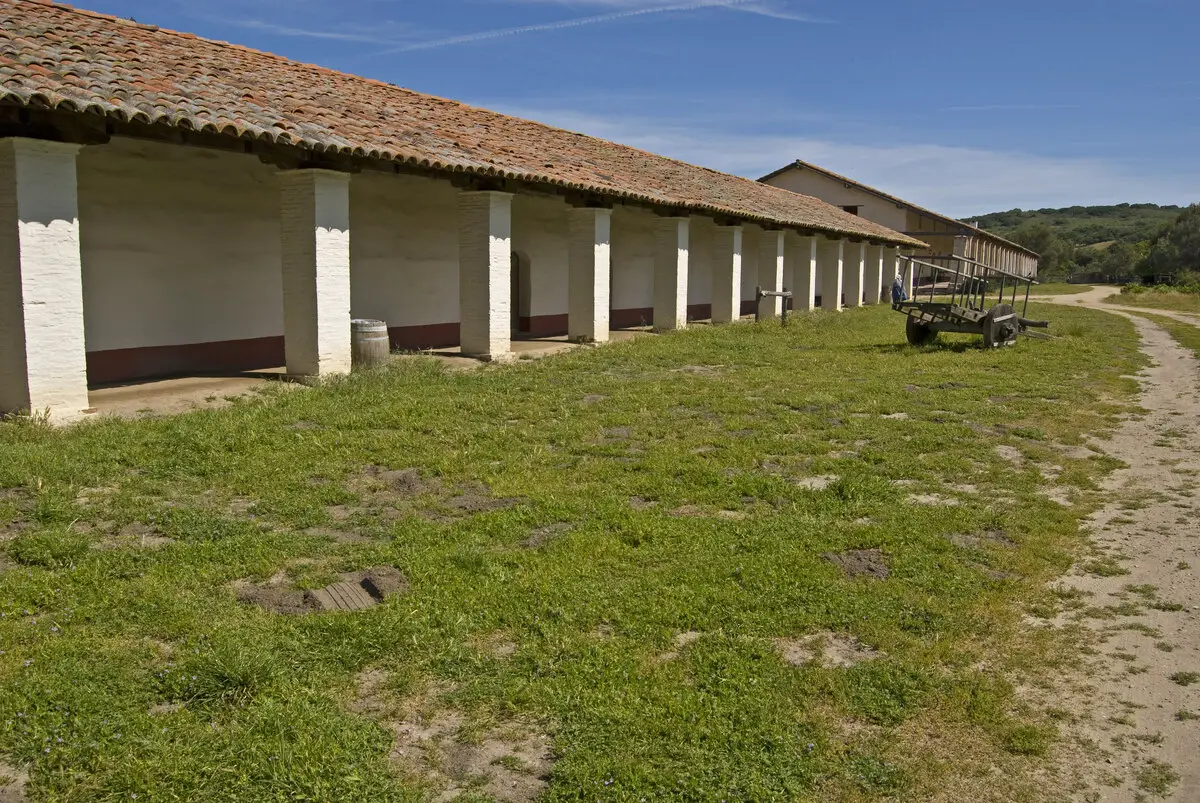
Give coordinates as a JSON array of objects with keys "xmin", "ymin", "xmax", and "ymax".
[{"xmin": 88, "ymin": 335, "xmax": 284, "ymax": 385}]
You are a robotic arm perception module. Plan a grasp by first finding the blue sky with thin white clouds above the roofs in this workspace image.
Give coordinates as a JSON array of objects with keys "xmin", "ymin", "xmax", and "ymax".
[{"xmin": 77, "ymin": 0, "xmax": 1200, "ymax": 217}]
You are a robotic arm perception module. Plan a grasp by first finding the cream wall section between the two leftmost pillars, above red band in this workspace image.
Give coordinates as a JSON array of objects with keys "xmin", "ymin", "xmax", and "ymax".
[{"xmin": 78, "ymin": 138, "xmax": 283, "ymax": 352}]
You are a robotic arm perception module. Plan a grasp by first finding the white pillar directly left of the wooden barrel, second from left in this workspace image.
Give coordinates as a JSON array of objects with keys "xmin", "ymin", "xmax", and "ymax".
[{"xmin": 278, "ymin": 170, "xmax": 350, "ymax": 377}]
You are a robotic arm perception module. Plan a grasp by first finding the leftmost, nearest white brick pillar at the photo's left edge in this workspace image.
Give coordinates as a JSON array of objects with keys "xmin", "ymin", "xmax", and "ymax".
[{"xmin": 0, "ymin": 138, "xmax": 88, "ymax": 423}]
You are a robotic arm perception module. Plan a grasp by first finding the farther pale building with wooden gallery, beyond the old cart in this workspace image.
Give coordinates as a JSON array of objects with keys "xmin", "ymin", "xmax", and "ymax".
[{"xmin": 760, "ymin": 160, "xmax": 1038, "ymax": 295}]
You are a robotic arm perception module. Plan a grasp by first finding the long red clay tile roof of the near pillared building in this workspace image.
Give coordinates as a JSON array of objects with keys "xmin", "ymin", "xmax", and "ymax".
[{"xmin": 0, "ymin": 0, "xmax": 923, "ymax": 247}]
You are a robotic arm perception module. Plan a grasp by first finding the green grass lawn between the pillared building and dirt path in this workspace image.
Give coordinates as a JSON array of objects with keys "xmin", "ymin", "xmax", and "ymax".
[{"xmin": 0, "ymin": 307, "xmax": 1141, "ymax": 802}]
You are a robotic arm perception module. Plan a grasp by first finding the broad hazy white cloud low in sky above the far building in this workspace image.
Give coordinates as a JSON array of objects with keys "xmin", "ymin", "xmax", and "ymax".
[{"xmin": 493, "ymin": 104, "xmax": 1200, "ymax": 218}]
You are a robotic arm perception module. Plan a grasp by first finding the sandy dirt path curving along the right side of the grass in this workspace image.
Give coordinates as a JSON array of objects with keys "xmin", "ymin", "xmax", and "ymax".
[{"xmin": 1032, "ymin": 288, "xmax": 1200, "ymax": 803}]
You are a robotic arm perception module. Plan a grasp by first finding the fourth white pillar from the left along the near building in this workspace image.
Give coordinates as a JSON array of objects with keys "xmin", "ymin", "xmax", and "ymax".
[{"xmin": 566, "ymin": 208, "xmax": 612, "ymax": 343}]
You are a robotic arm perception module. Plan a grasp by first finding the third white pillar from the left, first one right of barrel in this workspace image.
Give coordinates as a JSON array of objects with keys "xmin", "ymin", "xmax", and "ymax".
[{"xmin": 458, "ymin": 192, "xmax": 512, "ymax": 361}]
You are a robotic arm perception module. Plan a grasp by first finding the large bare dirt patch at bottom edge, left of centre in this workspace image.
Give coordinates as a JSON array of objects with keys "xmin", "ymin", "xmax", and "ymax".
[{"xmin": 348, "ymin": 670, "xmax": 554, "ymax": 803}]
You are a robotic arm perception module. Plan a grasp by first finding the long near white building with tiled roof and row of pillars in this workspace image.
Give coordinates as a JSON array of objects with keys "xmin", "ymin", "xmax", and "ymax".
[{"xmin": 0, "ymin": 0, "xmax": 924, "ymax": 421}]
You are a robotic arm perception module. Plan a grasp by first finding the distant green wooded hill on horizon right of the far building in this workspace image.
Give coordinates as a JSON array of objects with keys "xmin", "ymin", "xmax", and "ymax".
[{"xmin": 968, "ymin": 204, "xmax": 1182, "ymax": 246}]
